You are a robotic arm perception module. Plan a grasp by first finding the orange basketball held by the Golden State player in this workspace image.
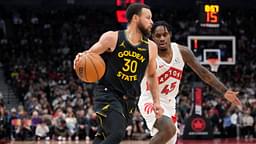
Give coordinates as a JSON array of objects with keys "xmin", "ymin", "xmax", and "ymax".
[{"xmin": 75, "ymin": 53, "xmax": 106, "ymax": 83}]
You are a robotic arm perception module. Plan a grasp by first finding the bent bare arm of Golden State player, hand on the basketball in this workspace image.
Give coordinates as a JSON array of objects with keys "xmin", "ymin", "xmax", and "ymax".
[{"xmin": 73, "ymin": 31, "xmax": 118, "ymax": 69}]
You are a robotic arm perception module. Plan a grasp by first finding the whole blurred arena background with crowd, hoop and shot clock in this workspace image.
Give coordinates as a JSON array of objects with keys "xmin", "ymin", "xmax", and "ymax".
[{"xmin": 0, "ymin": 0, "xmax": 256, "ymax": 141}]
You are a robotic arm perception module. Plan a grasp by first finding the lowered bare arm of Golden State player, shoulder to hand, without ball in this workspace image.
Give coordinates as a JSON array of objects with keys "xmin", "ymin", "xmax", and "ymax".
[{"xmin": 146, "ymin": 41, "xmax": 163, "ymax": 118}]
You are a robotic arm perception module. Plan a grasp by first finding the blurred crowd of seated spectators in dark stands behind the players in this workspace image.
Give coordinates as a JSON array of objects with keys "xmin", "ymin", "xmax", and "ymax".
[{"xmin": 0, "ymin": 8, "xmax": 256, "ymax": 140}]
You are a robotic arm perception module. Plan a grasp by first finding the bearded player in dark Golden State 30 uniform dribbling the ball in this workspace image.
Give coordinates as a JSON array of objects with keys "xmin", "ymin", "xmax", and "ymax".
[{"xmin": 74, "ymin": 3, "xmax": 163, "ymax": 144}]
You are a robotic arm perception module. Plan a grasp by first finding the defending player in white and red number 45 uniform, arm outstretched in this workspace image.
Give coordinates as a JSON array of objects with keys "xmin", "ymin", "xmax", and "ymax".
[{"xmin": 138, "ymin": 21, "xmax": 241, "ymax": 144}]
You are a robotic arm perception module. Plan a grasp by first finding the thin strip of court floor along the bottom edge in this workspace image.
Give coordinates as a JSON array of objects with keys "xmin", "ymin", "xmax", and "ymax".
[{"xmin": 0, "ymin": 138, "xmax": 256, "ymax": 144}]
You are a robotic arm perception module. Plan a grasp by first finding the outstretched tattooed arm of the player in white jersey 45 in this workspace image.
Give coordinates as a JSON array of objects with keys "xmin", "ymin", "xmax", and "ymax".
[{"xmin": 179, "ymin": 45, "xmax": 241, "ymax": 106}]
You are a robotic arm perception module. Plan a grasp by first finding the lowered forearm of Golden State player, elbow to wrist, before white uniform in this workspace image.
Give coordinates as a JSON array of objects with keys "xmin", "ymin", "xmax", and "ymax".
[{"xmin": 148, "ymin": 75, "xmax": 160, "ymax": 103}]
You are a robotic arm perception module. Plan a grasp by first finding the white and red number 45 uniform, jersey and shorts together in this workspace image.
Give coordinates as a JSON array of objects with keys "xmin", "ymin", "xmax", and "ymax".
[{"xmin": 138, "ymin": 43, "xmax": 184, "ymax": 137}]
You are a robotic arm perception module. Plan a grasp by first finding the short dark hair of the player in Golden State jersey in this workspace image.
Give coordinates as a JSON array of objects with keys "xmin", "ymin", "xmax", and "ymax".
[{"xmin": 126, "ymin": 3, "xmax": 150, "ymax": 23}]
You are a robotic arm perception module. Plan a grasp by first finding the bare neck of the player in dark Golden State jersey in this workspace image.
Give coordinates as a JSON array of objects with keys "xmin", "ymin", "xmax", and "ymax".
[{"xmin": 125, "ymin": 24, "xmax": 142, "ymax": 45}]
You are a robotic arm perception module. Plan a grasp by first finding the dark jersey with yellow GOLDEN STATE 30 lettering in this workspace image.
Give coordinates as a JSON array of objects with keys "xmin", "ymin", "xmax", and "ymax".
[{"xmin": 99, "ymin": 31, "xmax": 149, "ymax": 97}]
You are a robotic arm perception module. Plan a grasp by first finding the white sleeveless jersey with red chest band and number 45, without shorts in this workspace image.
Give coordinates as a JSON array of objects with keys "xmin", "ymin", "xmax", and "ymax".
[{"xmin": 141, "ymin": 43, "xmax": 184, "ymax": 109}]
